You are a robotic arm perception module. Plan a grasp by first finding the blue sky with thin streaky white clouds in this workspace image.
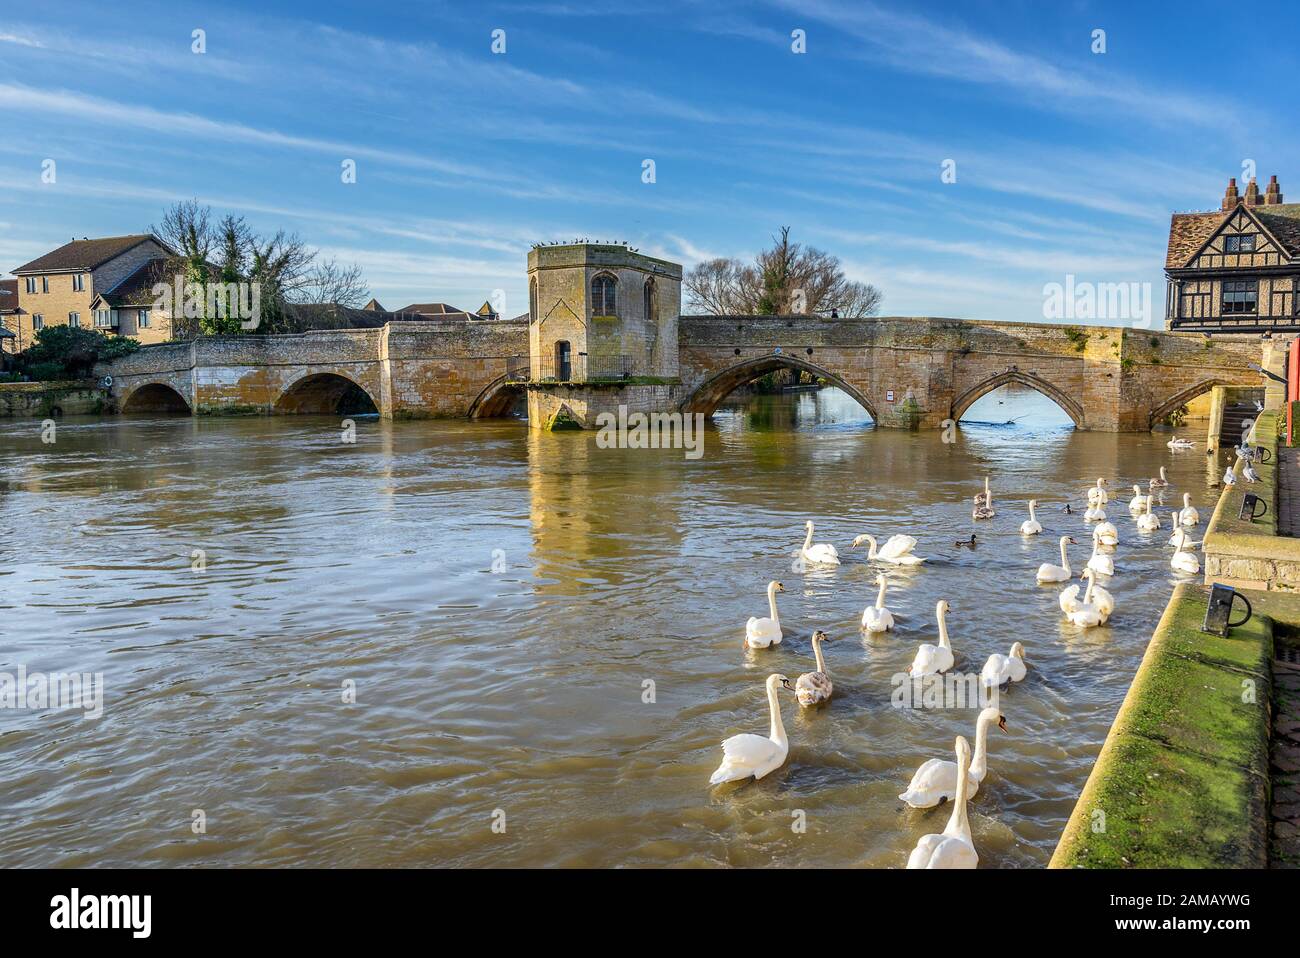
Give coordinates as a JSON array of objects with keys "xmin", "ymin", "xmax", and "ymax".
[{"xmin": 0, "ymin": 0, "xmax": 1300, "ymax": 322}]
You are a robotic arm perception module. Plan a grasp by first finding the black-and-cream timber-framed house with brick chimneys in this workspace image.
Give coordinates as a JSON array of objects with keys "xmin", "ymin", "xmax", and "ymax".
[{"xmin": 1165, "ymin": 177, "xmax": 1300, "ymax": 333}]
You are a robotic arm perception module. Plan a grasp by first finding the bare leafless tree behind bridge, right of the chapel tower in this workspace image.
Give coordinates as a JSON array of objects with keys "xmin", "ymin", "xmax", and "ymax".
[{"xmin": 683, "ymin": 226, "xmax": 884, "ymax": 318}]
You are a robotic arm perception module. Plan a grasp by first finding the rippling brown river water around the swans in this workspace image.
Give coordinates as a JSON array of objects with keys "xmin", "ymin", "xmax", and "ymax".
[{"xmin": 0, "ymin": 389, "xmax": 1221, "ymax": 867}]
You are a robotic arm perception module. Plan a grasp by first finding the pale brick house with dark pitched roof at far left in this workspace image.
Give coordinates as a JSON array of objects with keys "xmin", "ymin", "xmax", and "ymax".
[{"xmin": 13, "ymin": 234, "xmax": 174, "ymax": 350}]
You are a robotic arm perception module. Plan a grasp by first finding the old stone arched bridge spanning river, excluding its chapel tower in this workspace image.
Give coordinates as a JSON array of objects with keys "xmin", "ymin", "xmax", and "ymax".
[{"xmin": 98, "ymin": 316, "xmax": 1261, "ymax": 432}]
